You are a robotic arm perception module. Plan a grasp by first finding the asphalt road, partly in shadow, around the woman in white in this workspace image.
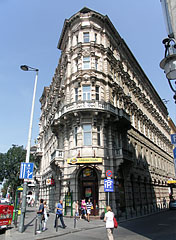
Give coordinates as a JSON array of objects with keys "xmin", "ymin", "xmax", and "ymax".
[{"xmin": 56, "ymin": 210, "xmax": 176, "ymax": 240}]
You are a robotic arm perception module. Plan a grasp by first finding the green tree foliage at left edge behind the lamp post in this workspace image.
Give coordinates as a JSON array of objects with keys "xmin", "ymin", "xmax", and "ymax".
[{"xmin": 0, "ymin": 145, "xmax": 36, "ymax": 199}]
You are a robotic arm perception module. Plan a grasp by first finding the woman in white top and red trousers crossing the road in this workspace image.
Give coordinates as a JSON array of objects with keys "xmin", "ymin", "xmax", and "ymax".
[{"xmin": 104, "ymin": 206, "xmax": 114, "ymax": 240}]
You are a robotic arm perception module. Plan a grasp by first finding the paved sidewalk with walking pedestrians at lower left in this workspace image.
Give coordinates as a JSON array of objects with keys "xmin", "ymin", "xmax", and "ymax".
[{"xmin": 5, "ymin": 207, "xmax": 105, "ymax": 240}]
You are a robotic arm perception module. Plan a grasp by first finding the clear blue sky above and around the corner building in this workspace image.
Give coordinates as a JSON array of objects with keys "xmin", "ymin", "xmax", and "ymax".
[{"xmin": 0, "ymin": 0, "xmax": 176, "ymax": 152}]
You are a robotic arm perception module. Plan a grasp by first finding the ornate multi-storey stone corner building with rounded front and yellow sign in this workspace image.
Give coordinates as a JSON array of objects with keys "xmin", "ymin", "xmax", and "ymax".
[{"xmin": 38, "ymin": 8, "xmax": 175, "ymax": 216}]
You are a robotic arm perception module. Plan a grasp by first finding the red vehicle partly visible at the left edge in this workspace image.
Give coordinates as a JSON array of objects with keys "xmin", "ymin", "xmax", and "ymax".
[{"xmin": 0, "ymin": 204, "xmax": 13, "ymax": 229}]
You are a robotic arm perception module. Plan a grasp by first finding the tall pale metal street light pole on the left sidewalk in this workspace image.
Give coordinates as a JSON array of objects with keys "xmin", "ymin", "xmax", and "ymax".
[{"xmin": 18, "ymin": 65, "xmax": 39, "ymax": 233}]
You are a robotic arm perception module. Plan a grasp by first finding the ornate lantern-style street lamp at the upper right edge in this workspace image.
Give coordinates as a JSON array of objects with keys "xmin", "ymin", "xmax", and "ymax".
[{"xmin": 160, "ymin": 38, "xmax": 176, "ymax": 100}]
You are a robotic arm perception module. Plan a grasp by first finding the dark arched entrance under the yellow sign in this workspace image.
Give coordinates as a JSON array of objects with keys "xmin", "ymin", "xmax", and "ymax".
[{"xmin": 78, "ymin": 167, "xmax": 98, "ymax": 215}]
